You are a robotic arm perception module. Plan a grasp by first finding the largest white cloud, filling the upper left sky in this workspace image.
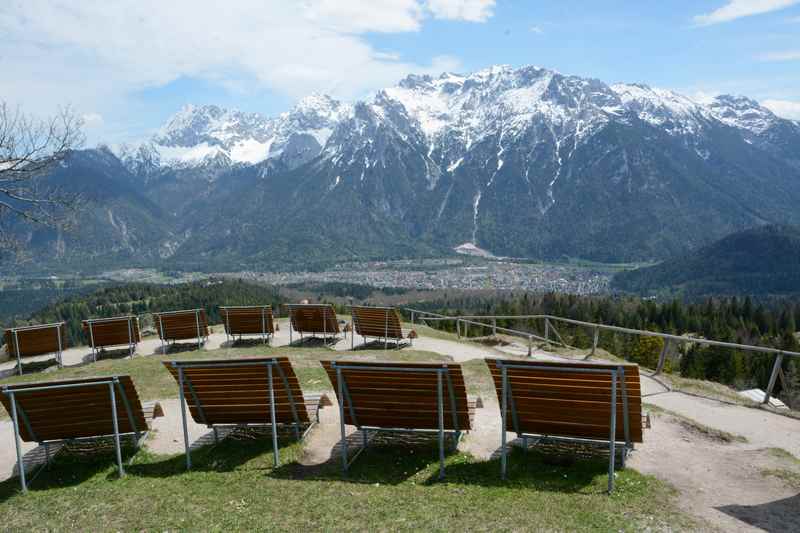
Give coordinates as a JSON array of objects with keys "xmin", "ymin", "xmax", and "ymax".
[{"xmin": 0, "ymin": 0, "xmax": 494, "ymax": 141}]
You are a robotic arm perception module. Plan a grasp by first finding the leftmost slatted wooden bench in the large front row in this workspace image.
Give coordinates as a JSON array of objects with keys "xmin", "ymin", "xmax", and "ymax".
[{"xmin": 0, "ymin": 376, "xmax": 163, "ymax": 491}]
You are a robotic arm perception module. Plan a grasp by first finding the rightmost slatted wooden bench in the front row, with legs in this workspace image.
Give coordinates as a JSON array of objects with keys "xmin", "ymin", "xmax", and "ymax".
[{"xmin": 486, "ymin": 359, "xmax": 642, "ymax": 492}]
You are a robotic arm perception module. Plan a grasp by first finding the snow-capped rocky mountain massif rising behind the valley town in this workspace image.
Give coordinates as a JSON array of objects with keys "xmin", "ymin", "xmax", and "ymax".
[{"xmin": 10, "ymin": 66, "xmax": 800, "ymax": 269}]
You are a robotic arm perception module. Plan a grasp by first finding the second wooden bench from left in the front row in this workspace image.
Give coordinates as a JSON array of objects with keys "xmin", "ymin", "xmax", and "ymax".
[{"xmin": 164, "ymin": 357, "xmax": 330, "ymax": 468}]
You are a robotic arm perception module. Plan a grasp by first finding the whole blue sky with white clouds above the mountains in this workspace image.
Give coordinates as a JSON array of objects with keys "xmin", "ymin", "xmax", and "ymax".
[{"xmin": 0, "ymin": 0, "xmax": 800, "ymax": 144}]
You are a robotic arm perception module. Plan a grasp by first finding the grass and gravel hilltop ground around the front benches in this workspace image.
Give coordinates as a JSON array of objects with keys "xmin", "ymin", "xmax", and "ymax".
[{"xmin": 0, "ymin": 320, "xmax": 800, "ymax": 531}]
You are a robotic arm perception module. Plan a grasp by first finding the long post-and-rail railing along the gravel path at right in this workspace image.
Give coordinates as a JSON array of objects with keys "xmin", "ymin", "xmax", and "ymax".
[{"xmin": 403, "ymin": 308, "xmax": 800, "ymax": 404}]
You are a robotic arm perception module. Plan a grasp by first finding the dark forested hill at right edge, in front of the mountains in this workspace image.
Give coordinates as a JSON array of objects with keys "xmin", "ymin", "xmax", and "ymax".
[{"xmin": 612, "ymin": 225, "xmax": 800, "ymax": 294}]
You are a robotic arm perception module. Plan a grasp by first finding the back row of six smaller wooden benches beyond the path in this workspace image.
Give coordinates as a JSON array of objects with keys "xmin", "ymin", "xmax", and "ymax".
[{"xmin": 0, "ymin": 304, "xmax": 410, "ymax": 374}]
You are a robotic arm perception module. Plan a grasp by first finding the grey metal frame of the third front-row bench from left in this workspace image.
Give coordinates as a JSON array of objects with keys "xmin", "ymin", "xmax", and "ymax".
[{"xmin": 331, "ymin": 361, "xmax": 461, "ymax": 479}]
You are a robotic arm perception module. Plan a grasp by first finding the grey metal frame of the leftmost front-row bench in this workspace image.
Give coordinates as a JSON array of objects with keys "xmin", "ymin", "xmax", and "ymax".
[{"xmin": 0, "ymin": 376, "xmax": 149, "ymax": 492}]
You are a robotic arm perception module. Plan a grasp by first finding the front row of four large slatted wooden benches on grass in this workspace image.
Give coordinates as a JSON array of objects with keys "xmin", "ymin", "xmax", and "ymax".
[{"xmin": 0, "ymin": 357, "xmax": 643, "ymax": 491}]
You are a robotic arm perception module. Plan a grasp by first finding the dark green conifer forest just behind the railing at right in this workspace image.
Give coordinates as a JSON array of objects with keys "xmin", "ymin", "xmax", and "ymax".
[{"xmin": 417, "ymin": 293, "xmax": 800, "ymax": 400}]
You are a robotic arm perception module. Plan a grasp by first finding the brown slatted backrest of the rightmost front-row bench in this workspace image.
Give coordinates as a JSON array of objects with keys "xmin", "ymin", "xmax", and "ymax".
[{"xmin": 486, "ymin": 359, "xmax": 642, "ymax": 442}]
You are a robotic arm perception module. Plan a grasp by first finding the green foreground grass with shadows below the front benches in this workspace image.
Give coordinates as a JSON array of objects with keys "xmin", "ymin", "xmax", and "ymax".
[{"xmin": 0, "ymin": 438, "xmax": 696, "ymax": 531}]
